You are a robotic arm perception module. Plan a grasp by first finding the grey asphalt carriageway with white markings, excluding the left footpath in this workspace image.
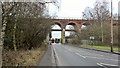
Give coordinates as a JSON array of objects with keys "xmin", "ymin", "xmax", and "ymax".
[{"xmin": 52, "ymin": 44, "xmax": 120, "ymax": 68}]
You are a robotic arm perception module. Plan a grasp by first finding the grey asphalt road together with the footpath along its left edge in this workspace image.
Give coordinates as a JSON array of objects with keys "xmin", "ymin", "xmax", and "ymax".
[{"xmin": 40, "ymin": 44, "xmax": 120, "ymax": 68}]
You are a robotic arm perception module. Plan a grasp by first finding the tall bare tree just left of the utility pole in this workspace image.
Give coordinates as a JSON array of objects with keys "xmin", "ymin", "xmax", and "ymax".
[{"xmin": 80, "ymin": 0, "xmax": 110, "ymax": 43}]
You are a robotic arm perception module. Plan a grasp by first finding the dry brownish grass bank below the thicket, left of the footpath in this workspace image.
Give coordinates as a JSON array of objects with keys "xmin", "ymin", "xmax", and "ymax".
[{"xmin": 2, "ymin": 47, "xmax": 46, "ymax": 66}]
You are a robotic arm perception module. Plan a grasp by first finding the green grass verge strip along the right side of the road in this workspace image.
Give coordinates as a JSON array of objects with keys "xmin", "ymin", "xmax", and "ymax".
[{"xmin": 80, "ymin": 44, "xmax": 119, "ymax": 52}]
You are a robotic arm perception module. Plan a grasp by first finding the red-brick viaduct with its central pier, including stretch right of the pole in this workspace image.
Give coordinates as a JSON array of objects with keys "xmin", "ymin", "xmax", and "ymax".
[{"xmin": 51, "ymin": 19, "xmax": 118, "ymax": 44}]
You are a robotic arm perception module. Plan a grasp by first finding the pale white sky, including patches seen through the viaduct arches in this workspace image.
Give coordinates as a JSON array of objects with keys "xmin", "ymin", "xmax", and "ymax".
[{"xmin": 49, "ymin": 0, "xmax": 120, "ymax": 38}]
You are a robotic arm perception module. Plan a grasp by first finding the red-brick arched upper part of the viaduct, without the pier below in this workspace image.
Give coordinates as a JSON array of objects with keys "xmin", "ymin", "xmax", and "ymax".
[{"xmin": 52, "ymin": 19, "xmax": 90, "ymax": 29}]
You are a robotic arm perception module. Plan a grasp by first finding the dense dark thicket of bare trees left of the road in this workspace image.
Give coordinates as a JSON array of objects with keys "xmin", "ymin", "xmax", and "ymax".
[{"xmin": 2, "ymin": 2, "xmax": 60, "ymax": 50}]
